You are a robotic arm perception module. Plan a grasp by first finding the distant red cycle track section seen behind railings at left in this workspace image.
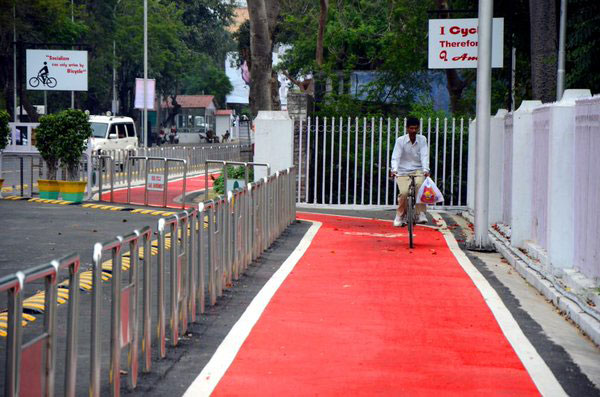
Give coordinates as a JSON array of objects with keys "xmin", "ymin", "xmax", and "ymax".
[{"xmin": 102, "ymin": 173, "xmax": 220, "ymax": 208}]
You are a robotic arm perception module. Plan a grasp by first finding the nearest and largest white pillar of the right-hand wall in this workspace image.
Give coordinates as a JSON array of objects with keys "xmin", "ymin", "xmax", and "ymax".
[{"xmin": 548, "ymin": 90, "xmax": 592, "ymax": 268}]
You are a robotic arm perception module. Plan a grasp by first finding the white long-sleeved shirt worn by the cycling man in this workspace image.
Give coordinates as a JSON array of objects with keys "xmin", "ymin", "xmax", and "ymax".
[{"xmin": 391, "ymin": 134, "xmax": 429, "ymax": 175}]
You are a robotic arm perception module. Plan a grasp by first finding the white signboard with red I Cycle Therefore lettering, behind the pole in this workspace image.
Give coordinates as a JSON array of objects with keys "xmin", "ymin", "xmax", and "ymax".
[{"xmin": 429, "ymin": 18, "xmax": 504, "ymax": 69}]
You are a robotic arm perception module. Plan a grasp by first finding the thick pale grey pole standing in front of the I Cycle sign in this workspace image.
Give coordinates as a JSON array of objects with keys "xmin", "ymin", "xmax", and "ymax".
[{"xmin": 469, "ymin": 0, "xmax": 494, "ymax": 251}]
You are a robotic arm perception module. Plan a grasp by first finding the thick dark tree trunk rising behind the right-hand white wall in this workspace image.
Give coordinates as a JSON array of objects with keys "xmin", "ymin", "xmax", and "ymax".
[{"xmin": 529, "ymin": 0, "xmax": 557, "ymax": 102}]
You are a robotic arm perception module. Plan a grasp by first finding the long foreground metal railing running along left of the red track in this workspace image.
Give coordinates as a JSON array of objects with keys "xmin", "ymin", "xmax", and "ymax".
[{"xmin": 0, "ymin": 168, "xmax": 297, "ymax": 396}]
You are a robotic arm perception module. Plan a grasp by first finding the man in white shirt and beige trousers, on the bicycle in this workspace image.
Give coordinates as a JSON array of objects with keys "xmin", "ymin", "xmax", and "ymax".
[{"xmin": 390, "ymin": 117, "xmax": 429, "ymax": 227}]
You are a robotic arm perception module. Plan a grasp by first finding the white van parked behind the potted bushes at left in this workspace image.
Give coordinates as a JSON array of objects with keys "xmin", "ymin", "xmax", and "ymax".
[{"xmin": 89, "ymin": 116, "xmax": 138, "ymax": 154}]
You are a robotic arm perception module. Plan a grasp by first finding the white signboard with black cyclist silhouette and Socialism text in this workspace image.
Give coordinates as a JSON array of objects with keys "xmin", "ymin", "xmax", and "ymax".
[{"xmin": 26, "ymin": 50, "xmax": 88, "ymax": 91}]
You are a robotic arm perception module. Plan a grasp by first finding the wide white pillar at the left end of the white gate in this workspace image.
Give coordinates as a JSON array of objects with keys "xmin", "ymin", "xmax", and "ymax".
[{"xmin": 254, "ymin": 110, "xmax": 294, "ymax": 181}]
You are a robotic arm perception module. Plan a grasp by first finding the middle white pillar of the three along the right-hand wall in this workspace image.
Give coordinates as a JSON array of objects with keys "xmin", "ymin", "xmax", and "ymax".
[{"xmin": 510, "ymin": 101, "xmax": 542, "ymax": 247}]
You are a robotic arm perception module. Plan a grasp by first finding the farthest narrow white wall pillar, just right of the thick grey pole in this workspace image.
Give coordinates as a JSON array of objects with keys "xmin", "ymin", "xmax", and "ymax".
[{"xmin": 489, "ymin": 109, "xmax": 508, "ymax": 225}]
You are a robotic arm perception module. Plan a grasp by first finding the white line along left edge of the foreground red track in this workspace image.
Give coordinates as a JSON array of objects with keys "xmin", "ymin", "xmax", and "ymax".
[{"xmin": 184, "ymin": 221, "xmax": 322, "ymax": 397}]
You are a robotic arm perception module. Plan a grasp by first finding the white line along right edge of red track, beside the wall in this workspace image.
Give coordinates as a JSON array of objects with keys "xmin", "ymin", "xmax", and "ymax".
[{"xmin": 432, "ymin": 214, "xmax": 567, "ymax": 396}]
